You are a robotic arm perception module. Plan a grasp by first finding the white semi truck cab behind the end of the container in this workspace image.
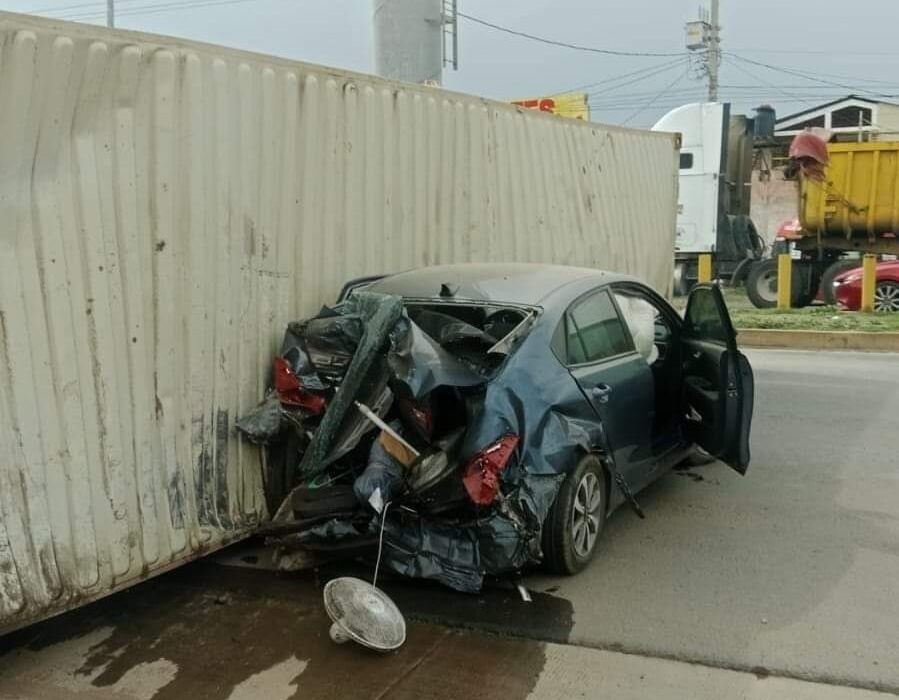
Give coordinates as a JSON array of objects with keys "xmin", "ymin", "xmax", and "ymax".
[{"xmin": 652, "ymin": 102, "xmax": 774, "ymax": 295}]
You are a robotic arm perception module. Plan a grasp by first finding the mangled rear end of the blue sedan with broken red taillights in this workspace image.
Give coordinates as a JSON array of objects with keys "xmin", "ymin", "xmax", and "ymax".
[{"xmin": 238, "ymin": 291, "xmax": 600, "ymax": 592}]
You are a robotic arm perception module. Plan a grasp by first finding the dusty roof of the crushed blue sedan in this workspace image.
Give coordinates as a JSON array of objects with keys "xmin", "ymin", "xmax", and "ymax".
[{"xmin": 368, "ymin": 263, "xmax": 633, "ymax": 306}]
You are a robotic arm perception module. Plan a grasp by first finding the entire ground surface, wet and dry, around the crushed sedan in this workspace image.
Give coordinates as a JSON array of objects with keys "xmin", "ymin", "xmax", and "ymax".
[{"xmin": 0, "ymin": 351, "xmax": 899, "ymax": 700}]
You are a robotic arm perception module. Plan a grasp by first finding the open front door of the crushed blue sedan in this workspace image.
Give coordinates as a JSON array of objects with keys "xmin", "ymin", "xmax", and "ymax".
[{"xmin": 682, "ymin": 284, "xmax": 754, "ymax": 474}]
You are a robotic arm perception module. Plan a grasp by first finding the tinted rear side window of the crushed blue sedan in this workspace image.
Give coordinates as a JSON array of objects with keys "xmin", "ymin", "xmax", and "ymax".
[{"xmin": 565, "ymin": 290, "xmax": 634, "ymax": 365}]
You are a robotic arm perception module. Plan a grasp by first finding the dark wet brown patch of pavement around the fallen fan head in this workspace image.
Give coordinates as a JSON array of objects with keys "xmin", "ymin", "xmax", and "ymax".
[{"xmin": 0, "ymin": 562, "xmax": 571, "ymax": 700}]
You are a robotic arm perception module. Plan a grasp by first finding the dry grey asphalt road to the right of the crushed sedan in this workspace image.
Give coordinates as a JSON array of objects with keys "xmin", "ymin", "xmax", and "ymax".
[{"xmin": 530, "ymin": 351, "xmax": 899, "ymax": 692}]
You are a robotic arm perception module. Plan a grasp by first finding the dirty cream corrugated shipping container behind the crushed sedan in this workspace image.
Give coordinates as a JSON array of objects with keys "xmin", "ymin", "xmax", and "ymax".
[{"xmin": 0, "ymin": 14, "xmax": 677, "ymax": 631}]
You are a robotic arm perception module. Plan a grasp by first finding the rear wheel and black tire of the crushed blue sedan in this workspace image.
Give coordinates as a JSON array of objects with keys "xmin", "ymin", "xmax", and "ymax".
[{"xmin": 543, "ymin": 455, "xmax": 609, "ymax": 575}]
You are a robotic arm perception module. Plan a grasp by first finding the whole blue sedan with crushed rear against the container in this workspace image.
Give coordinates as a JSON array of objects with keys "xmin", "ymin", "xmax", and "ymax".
[{"xmin": 238, "ymin": 264, "xmax": 753, "ymax": 592}]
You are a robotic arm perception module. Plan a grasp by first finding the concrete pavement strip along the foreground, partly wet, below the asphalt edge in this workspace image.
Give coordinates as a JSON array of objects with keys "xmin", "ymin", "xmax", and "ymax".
[{"xmin": 0, "ymin": 564, "xmax": 891, "ymax": 700}]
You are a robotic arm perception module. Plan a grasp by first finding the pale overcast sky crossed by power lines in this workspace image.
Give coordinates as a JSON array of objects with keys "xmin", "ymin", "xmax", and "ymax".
[{"xmin": 7, "ymin": 0, "xmax": 899, "ymax": 126}]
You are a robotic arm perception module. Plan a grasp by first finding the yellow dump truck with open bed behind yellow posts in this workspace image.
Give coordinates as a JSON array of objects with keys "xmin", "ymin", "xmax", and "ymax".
[{"xmin": 746, "ymin": 141, "xmax": 899, "ymax": 308}]
